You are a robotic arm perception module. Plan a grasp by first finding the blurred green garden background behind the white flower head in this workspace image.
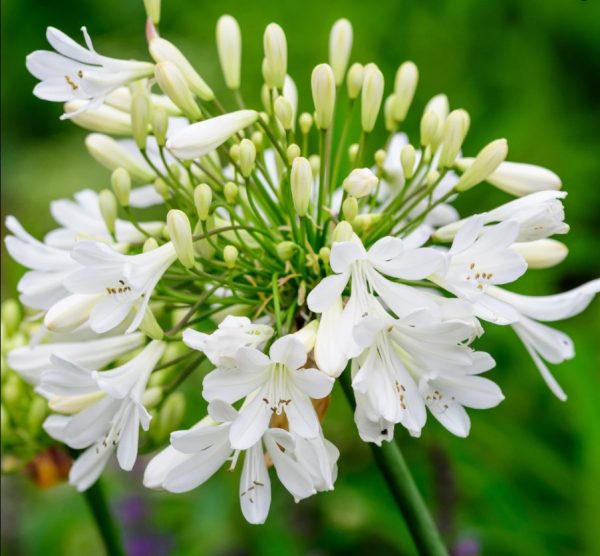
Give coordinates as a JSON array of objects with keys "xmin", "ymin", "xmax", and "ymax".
[{"xmin": 1, "ymin": 0, "xmax": 600, "ymax": 556}]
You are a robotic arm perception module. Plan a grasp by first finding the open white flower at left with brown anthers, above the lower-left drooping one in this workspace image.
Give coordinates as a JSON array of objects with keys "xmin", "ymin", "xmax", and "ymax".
[{"xmin": 44, "ymin": 241, "xmax": 177, "ymax": 333}]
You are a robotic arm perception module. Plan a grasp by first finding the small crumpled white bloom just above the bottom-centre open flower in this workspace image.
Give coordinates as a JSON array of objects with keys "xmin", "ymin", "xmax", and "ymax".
[{"xmin": 183, "ymin": 315, "xmax": 273, "ymax": 368}]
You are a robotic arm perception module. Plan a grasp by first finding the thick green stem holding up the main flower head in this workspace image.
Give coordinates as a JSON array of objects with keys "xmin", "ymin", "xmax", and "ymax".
[{"xmin": 340, "ymin": 367, "xmax": 448, "ymax": 556}]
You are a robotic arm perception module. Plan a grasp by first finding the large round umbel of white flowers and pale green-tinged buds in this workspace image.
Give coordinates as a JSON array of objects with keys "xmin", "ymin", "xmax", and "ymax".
[{"xmin": 6, "ymin": 2, "xmax": 600, "ymax": 523}]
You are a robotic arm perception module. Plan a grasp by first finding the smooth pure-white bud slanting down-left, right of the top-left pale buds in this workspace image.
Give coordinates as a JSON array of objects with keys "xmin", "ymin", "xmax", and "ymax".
[{"xmin": 167, "ymin": 110, "xmax": 258, "ymax": 160}]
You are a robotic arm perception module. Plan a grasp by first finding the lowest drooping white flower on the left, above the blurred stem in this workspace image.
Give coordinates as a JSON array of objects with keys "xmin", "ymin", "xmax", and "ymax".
[{"xmin": 40, "ymin": 341, "xmax": 165, "ymax": 490}]
